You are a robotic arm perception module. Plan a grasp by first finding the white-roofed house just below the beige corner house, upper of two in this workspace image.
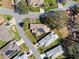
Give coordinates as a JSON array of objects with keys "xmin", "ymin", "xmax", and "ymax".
[{"xmin": 38, "ymin": 32, "xmax": 58, "ymax": 47}]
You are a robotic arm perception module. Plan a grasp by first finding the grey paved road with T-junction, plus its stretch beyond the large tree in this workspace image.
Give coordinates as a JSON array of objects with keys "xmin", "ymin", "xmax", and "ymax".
[{"xmin": 0, "ymin": 2, "xmax": 76, "ymax": 59}]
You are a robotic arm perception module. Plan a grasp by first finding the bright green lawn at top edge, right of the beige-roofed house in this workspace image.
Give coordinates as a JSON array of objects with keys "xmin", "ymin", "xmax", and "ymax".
[{"xmin": 44, "ymin": 0, "xmax": 58, "ymax": 11}]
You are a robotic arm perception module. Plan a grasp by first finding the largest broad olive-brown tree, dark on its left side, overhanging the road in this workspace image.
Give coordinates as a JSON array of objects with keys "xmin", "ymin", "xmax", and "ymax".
[{"xmin": 40, "ymin": 11, "xmax": 68, "ymax": 29}]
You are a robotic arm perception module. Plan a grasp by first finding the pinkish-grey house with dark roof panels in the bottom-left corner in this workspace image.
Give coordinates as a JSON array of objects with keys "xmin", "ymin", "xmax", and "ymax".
[{"xmin": 0, "ymin": 41, "xmax": 20, "ymax": 59}]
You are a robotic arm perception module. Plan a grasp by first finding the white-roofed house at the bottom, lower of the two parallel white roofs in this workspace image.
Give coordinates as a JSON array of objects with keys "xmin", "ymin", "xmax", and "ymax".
[{"xmin": 45, "ymin": 45, "xmax": 64, "ymax": 59}]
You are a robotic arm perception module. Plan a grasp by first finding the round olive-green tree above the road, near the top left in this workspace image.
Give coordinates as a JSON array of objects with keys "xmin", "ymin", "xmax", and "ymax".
[{"xmin": 17, "ymin": 0, "xmax": 28, "ymax": 14}]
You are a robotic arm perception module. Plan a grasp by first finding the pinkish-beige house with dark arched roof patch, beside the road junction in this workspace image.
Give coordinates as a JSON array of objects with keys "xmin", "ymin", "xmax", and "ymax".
[{"xmin": 30, "ymin": 24, "xmax": 50, "ymax": 36}]
